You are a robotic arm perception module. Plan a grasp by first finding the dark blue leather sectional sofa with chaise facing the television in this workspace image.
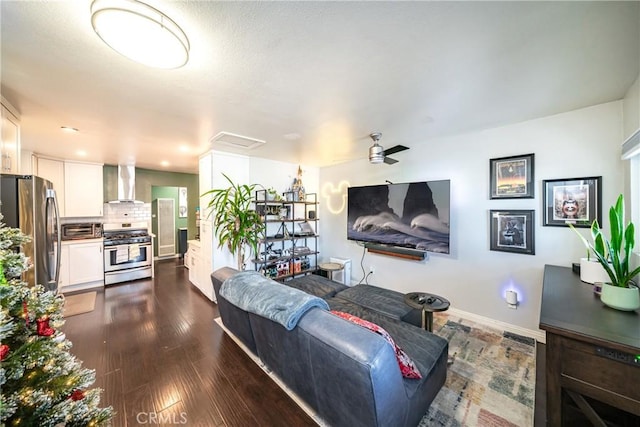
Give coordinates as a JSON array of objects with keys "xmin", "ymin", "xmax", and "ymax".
[{"xmin": 211, "ymin": 268, "xmax": 448, "ymax": 427}]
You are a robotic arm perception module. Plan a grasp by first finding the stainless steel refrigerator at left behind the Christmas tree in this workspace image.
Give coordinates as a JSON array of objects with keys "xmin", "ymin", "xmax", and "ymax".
[{"xmin": 0, "ymin": 174, "xmax": 61, "ymax": 292}]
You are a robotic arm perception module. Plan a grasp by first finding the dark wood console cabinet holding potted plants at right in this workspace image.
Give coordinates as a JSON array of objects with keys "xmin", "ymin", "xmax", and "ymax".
[{"xmin": 540, "ymin": 265, "xmax": 640, "ymax": 427}]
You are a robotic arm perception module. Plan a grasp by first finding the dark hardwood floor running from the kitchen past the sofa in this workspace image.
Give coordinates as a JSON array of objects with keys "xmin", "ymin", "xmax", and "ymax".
[{"xmin": 62, "ymin": 260, "xmax": 546, "ymax": 427}]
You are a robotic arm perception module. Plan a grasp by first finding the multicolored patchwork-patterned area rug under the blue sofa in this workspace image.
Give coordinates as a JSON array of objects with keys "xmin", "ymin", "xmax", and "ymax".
[{"xmin": 215, "ymin": 313, "xmax": 536, "ymax": 427}]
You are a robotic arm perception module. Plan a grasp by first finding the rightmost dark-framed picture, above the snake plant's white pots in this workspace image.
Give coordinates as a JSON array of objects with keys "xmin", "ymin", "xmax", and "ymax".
[{"xmin": 542, "ymin": 176, "xmax": 602, "ymax": 228}]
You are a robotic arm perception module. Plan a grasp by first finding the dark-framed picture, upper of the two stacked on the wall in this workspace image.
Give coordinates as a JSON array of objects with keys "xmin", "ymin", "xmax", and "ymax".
[{"xmin": 489, "ymin": 153, "xmax": 535, "ymax": 199}]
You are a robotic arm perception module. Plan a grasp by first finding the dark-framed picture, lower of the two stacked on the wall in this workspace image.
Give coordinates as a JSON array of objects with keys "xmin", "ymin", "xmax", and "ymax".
[{"xmin": 489, "ymin": 210, "xmax": 536, "ymax": 255}]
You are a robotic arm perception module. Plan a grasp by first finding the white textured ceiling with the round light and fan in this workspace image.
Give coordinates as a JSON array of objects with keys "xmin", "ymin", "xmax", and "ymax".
[{"xmin": 0, "ymin": 0, "xmax": 640, "ymax": 173}]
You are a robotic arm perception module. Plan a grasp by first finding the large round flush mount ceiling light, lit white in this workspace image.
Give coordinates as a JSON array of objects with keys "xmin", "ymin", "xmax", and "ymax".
[{"xmin": 91, "ymin": 0, "xmax": 189, "ymax": 69}]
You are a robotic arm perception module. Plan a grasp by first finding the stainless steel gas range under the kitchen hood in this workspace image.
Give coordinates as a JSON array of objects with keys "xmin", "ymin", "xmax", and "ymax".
[{"xmin": 103, "ymin": 222, "xmax": 153, "ymax": 285}]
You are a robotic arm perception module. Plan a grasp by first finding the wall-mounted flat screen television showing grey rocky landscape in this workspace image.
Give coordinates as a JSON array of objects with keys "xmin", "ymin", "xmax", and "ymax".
[{"xmin": 347, "ymin": 180, "xmax": 451, "ymax": 254}]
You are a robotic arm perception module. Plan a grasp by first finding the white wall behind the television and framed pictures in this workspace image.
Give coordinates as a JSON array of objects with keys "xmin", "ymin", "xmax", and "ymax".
[{"xmin": 320, "ymin": 101, "xmax": 624, "ymax": 332}]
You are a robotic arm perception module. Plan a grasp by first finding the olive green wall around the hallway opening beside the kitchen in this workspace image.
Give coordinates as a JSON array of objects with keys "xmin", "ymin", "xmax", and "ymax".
[{"xmin": 103, "ymin": 165, "xmax": 200, "ymax": 242}]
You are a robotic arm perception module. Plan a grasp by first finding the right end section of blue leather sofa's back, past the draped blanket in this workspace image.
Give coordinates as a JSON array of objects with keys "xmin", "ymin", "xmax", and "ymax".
[{"xmin": 298, "ymin": 310, "xmax": 408, "ymax": 426}]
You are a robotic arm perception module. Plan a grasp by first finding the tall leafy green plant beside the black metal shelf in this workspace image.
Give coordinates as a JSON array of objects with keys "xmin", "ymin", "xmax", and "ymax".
[{"xmin": 203, "ymin": 174, "xmax": 264, "ymax": 270}]
